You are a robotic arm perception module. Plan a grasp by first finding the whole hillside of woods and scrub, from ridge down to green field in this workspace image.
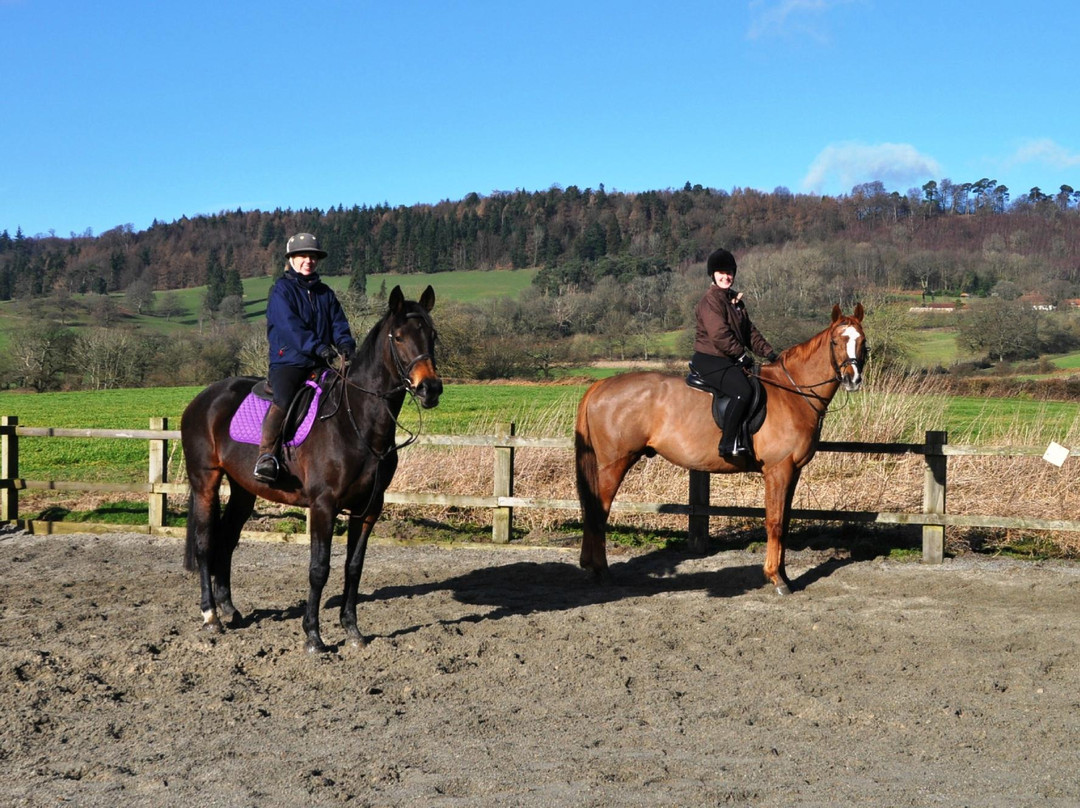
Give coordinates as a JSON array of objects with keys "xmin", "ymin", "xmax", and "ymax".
[{"xmin": 0, "ymin": 179, "xmax": 1080, "ymax": 390}]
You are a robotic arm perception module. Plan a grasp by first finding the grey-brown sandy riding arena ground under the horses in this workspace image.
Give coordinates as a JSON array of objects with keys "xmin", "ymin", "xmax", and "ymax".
[{"xmin": 0, "ymin": 530, "xmax": 1080, "ymax": 808}]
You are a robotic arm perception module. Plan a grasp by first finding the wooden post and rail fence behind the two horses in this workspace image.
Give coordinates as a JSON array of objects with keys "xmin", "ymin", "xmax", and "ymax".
[{"xmin": 0, "ymin": 416, "xmax": 1080, "ymax": 563}]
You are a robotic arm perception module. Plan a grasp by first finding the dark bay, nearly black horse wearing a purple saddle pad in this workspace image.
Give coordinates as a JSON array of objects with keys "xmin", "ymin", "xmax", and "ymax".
[{"xmin": 180, "ymin": 286, "xmax": 443, "ymax": 651}]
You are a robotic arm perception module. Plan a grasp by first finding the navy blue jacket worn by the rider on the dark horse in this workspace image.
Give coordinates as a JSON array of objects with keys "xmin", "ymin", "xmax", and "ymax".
[{"xmin": 267, "ymin": 267, "xmax": 356, "ymax": 367}]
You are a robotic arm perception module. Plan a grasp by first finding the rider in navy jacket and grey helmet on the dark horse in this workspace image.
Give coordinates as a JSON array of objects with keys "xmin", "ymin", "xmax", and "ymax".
[{"xmin": 255, "ymin": 233, "xmax": 356, "ymax": 483}]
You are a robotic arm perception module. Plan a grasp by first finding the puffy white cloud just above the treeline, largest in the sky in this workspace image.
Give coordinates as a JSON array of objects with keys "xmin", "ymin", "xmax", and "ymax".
[{"xmin": 802, "ymin": 143, "xmax": 941, "ymax": 193}]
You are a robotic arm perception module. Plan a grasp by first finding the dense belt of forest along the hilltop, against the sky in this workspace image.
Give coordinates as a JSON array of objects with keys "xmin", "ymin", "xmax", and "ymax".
[{"xmin": 0, "ymin": 179, "xmax": 1080, "ymax": 300}]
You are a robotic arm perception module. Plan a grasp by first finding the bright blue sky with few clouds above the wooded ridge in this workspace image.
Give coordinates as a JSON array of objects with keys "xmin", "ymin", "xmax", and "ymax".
[{"xmin": 6, "ymin": 0, "xmax": 1080, "ymax": 237}]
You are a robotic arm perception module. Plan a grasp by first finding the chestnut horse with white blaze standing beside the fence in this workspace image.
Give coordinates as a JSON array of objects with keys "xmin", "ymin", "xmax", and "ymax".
[{"xmin": 575, "ymin": 304, "xmax": 866, "ymax": 594}]
